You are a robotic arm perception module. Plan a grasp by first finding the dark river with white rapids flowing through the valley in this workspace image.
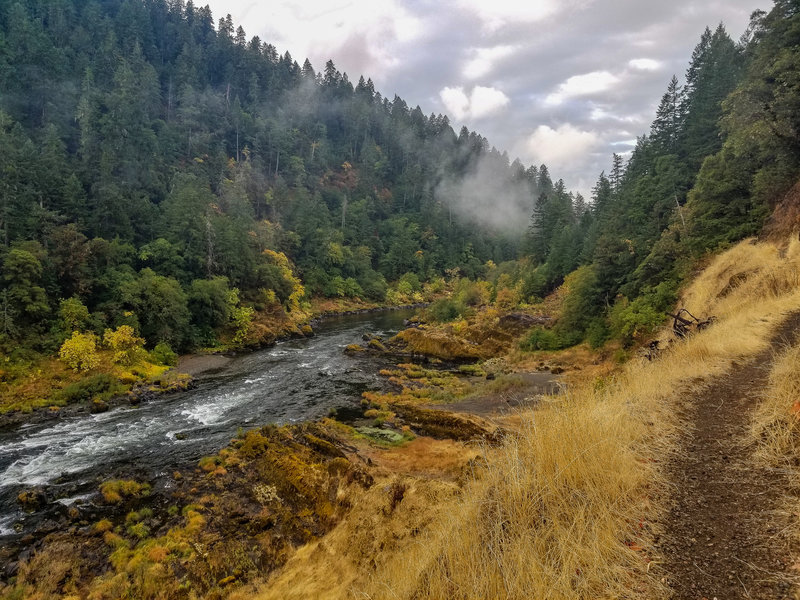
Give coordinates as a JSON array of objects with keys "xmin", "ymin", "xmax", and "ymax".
[{"xmin": 0, "ymin": 311, "xmax": 411, "ymax": 544}]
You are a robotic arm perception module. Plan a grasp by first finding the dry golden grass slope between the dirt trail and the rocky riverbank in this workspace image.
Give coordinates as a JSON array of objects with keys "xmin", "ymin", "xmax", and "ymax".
[{"xmin": 250, "ymin": 241, "xmax": 800, "ymax": 599}]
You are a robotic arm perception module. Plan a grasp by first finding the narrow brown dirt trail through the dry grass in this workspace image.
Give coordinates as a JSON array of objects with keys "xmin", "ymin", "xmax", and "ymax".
[{"xmin": 659, "ymin": 313, "xmax": 800, "ymax": 600}]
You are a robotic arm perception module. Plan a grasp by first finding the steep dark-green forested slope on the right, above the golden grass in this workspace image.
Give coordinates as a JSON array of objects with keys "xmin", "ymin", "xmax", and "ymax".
[{"xmin": 525, "ymin": 0, "xmax": 800, "ymax": 348}]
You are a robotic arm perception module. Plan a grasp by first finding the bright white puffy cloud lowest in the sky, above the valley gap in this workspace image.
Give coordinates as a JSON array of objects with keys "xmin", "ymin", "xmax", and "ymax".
[{"xmin": 521, "ymin": 123, "xmax": 601, "ymax": 170}]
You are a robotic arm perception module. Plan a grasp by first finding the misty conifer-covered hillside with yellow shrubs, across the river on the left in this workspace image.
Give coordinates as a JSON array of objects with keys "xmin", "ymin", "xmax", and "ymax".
[{"xmin": 0, "ymin": 0, "xmax": 566, "ymax": 352}]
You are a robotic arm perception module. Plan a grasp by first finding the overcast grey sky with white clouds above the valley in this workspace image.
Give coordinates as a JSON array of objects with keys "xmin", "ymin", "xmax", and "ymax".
[{"xmin": 202, "ymin": 0, "xmax": 771, "ymax": 194}]
